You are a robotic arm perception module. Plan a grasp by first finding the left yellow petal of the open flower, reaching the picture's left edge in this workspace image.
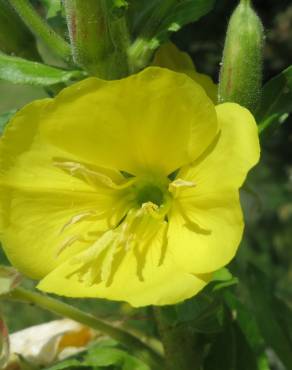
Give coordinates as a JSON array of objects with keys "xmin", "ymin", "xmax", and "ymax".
[{"xmin": 0, "ymin": 99, "xmax": 130, "ymax": 278}]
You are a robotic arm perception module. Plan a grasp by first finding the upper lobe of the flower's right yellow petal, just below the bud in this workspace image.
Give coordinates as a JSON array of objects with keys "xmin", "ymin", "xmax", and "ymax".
[{"xmin": 178, "ymin": 103, "xmax": 260, "ymax": 192}]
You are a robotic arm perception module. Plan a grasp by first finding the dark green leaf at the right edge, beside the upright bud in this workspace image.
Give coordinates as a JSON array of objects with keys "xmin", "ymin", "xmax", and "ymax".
[{"xmin": 256, "ymin": 66, "xmax": 292, "ymax": 132}]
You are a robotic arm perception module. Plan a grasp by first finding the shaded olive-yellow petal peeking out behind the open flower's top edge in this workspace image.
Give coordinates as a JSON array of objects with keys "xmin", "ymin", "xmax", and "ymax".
[{"xmin": 152, "ymin": 42, "xmax": 218, "ymax": 104}]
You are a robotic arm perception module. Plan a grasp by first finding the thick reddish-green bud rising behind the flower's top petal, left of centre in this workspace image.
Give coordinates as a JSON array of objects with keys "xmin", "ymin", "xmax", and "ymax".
[{"xmin": 64, "ymin": 0, "xmax": 129, "ymax": 79}]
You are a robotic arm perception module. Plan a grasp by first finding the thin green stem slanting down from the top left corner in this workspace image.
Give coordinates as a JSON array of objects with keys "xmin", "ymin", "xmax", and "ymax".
[{"xmin": 10, "ymin": 0, "xmax": 71, "ymax": 61}]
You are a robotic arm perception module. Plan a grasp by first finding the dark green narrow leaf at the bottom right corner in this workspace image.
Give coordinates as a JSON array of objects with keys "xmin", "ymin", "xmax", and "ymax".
[{"xmin": 246, "ymin": 266, "xmax": 292, "ymax": 369}]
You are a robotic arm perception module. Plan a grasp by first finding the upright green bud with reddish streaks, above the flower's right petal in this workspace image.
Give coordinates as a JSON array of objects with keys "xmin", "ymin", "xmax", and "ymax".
[{"xmin": 218, "ymin": 0, "xmax": 264, "ymax": 111}]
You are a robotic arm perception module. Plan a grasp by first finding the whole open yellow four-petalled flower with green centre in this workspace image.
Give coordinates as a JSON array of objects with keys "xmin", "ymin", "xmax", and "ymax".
[{"xmin": 0, "ymin": 67, "xmax": 259, "ymax": 306}]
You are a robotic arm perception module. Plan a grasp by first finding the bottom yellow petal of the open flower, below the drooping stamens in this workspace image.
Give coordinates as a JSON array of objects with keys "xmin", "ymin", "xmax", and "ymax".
[{"xmin": 38, "ymin": 224, "xmax": 211, "ymax": 307}]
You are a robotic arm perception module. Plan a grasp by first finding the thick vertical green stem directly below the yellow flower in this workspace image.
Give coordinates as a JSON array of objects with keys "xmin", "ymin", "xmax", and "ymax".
[{"xmin": 155, "ymin": 307, "xmax": 203, "ymax": 370}]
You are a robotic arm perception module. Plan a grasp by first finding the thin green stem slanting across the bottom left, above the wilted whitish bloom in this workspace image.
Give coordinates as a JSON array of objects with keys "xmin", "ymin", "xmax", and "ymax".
[{"xmin": 4, "ymin": 287, "xmax": 162, "ymax": 370}]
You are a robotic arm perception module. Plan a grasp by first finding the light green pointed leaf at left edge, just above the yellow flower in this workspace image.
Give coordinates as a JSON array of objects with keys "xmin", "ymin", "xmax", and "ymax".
[{"xmin": 0, "ymin": 54, "xmax": 85, "ymax": 86}]
